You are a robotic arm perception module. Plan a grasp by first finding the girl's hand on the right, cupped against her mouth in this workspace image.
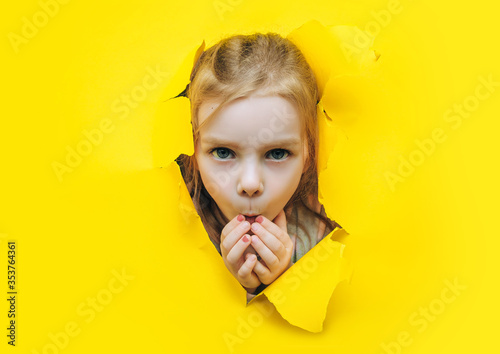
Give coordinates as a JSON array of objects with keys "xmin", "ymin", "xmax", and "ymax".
[{"xmin": 252, "ymin": 210, "xmax": 293, "ymax": 284}]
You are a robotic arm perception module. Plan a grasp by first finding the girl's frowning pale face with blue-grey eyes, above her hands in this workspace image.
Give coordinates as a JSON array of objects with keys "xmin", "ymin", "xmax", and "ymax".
[{"xmin": 195, "ymin": 95, "xmax": 308, "ymax": 221}]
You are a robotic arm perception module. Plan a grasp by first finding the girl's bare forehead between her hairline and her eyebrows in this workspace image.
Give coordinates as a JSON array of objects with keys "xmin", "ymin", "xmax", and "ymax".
[{"xmin": 198, "ymin": 95, "xmax": 301, "ymax": 142}]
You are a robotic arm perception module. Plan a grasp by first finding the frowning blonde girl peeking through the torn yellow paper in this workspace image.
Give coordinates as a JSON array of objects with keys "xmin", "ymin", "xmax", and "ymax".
[{"xmin": 176, "ymin": 33, "xmax": 340, "ymax": 301}]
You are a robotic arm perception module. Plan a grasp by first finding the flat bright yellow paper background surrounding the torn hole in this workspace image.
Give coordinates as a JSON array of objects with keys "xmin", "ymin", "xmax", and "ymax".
[{"xmin": 0, "ymin": 0, "xmax": 500, "ymax": 353}]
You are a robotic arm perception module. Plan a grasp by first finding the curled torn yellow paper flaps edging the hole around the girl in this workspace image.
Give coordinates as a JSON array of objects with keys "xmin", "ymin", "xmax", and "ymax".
[{"xmin": 153, "ymin": 21, "xmax": 379, "ymax": 332}]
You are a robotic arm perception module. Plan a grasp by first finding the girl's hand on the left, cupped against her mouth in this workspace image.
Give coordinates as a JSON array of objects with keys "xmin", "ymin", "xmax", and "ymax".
[{"xmin": 220, "ymin": 215, "xmax": 261, "ymax": 292}]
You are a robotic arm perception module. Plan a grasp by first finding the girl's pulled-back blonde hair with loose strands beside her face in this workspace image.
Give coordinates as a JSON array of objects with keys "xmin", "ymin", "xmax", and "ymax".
[{"xmin": 176, "ymin": 33, "xmax": 338, "ymax": 249}]
